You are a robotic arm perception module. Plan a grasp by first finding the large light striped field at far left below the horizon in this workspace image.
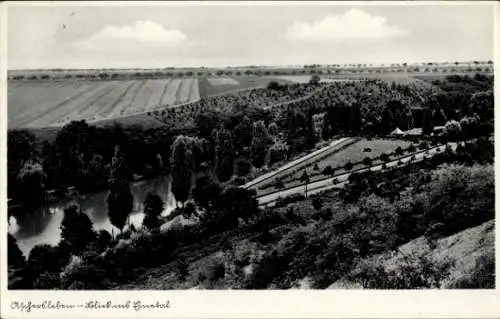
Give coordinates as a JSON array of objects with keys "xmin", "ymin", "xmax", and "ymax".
[{"xmin": 8, "ymin": 78, "xmax": 200, "ymax": 128}]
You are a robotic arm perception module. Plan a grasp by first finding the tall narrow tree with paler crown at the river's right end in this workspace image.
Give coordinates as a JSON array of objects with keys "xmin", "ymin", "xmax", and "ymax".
[{"xmin": 170, "ymin": 135, "xmax": 195, "ymax": 203}]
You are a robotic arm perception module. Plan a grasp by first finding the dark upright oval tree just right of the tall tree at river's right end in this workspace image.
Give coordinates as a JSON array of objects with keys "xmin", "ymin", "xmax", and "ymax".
[{"xmin": 215, "ymin": 129, "xmax": 234, "ymax": 182}]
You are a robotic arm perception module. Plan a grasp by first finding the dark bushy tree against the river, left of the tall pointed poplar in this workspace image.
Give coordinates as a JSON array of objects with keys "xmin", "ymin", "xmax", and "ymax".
[{"xmin": 60, "ymin": 205, "xmax": 96, "ymax": 255}]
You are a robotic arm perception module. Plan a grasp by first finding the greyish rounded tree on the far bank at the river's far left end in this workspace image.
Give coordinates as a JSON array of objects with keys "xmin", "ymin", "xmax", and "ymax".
[{"xmin": 17, "ymin": 160, "xmax": 46, "ymax": 213}]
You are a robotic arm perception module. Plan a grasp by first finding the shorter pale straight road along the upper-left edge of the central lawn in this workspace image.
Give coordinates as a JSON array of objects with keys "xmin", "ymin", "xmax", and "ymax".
[{"xmin": 241, "ymin": 137, "xmax": 356, "ymax": 188}]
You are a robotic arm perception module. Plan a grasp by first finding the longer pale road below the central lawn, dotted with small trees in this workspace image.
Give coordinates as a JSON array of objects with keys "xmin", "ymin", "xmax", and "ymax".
[{"xmin": 257, "ymin": 143, "xmax": 457, "ymax": 206}]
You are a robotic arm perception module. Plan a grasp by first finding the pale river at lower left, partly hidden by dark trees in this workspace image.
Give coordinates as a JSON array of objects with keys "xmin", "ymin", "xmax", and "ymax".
[{"xmin": 8, "ymin": 176, "xmax": 175, "ymax": 258}]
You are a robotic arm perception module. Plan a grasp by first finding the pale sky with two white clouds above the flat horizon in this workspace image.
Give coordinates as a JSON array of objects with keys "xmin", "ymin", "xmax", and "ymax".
[{"xmin": 7, "ymin": 2, "xmax": 494, "ymax": 69}]
